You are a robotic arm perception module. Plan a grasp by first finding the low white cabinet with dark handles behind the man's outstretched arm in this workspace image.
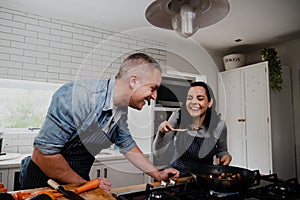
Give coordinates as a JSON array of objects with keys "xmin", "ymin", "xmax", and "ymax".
[{"xmin": 90, "ymin": 159, "xmax": 147, "ymax": 188}]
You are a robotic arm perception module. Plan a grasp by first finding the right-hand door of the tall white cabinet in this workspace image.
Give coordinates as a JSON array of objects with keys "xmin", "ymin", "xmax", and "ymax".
[{"xmin": 241, "ymin": 63, "xmax": 272, "ymax": 174}]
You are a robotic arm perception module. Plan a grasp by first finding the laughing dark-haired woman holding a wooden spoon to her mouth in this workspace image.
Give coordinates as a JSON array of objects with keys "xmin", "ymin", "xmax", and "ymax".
[{"xmin": 153, "ymin": 82, "xmax": 232, "ymax": 177}]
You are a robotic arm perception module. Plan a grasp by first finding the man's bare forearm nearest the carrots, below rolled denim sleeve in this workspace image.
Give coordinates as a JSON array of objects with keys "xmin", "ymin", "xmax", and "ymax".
[{"xmin": 32, "ymin": 149, "xmax": 86, "ymax": 183}]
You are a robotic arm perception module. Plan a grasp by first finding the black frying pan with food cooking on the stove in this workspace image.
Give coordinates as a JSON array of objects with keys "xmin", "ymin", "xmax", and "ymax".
[{"xmin": 190, "ymin": 165, "xmax": 260, "ymax": 192}]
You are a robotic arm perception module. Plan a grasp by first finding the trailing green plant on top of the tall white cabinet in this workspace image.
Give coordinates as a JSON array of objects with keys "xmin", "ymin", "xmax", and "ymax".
[{"xmin": 261, "ymin": 48, "xmax": 282, "ymax": 92}]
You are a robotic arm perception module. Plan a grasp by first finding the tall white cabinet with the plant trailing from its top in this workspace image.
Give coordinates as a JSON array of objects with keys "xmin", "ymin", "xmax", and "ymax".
[{"xmin": 218, "ymin": 62, "xmax": 295, "ymax": 178}]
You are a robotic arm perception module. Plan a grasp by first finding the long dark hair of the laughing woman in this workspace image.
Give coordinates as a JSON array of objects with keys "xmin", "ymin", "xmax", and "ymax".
[{"xmin": 180, "ymin": 81, "xmax": 220, "ymax": 130}]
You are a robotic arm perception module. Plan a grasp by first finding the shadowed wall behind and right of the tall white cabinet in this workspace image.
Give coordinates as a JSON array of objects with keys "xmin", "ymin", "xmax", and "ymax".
[{"xmin": 247, "ymin": 40, "xmax": 300, "ymax": 180}]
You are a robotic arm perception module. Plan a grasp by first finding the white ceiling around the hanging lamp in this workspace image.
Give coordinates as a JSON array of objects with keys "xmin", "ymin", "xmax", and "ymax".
[{"xmin": 0, "ymin": 0, "xmax": 300, "ymax": 53}]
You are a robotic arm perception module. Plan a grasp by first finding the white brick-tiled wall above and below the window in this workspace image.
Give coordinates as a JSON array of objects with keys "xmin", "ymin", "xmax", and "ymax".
[{"xmin": 0, "ymin": 7, "xmax": 166, "ymax": 153}]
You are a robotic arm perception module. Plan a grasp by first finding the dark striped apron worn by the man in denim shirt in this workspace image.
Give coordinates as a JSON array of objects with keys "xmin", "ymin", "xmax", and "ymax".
[{"xmin": 20, "ymin": 80, "xmax": 118, "ymax": 189}]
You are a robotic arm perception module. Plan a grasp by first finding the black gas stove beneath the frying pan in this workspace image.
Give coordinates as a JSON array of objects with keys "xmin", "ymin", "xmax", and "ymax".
[{"xmin": 117, "ymin": 174, "xmax": 300, "ymax": 200}]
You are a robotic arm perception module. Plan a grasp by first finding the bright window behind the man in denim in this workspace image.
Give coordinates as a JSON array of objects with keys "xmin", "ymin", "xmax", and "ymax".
[{"xmin": 0, "ymin": 79, "xmax": 61, "ymax": 129}]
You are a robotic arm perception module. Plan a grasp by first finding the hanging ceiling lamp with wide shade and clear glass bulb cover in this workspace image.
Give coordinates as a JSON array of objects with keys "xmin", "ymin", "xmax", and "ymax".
[{"xmin": 145, "ymin": 0, "xmax": 229, "ymax": 37}]
